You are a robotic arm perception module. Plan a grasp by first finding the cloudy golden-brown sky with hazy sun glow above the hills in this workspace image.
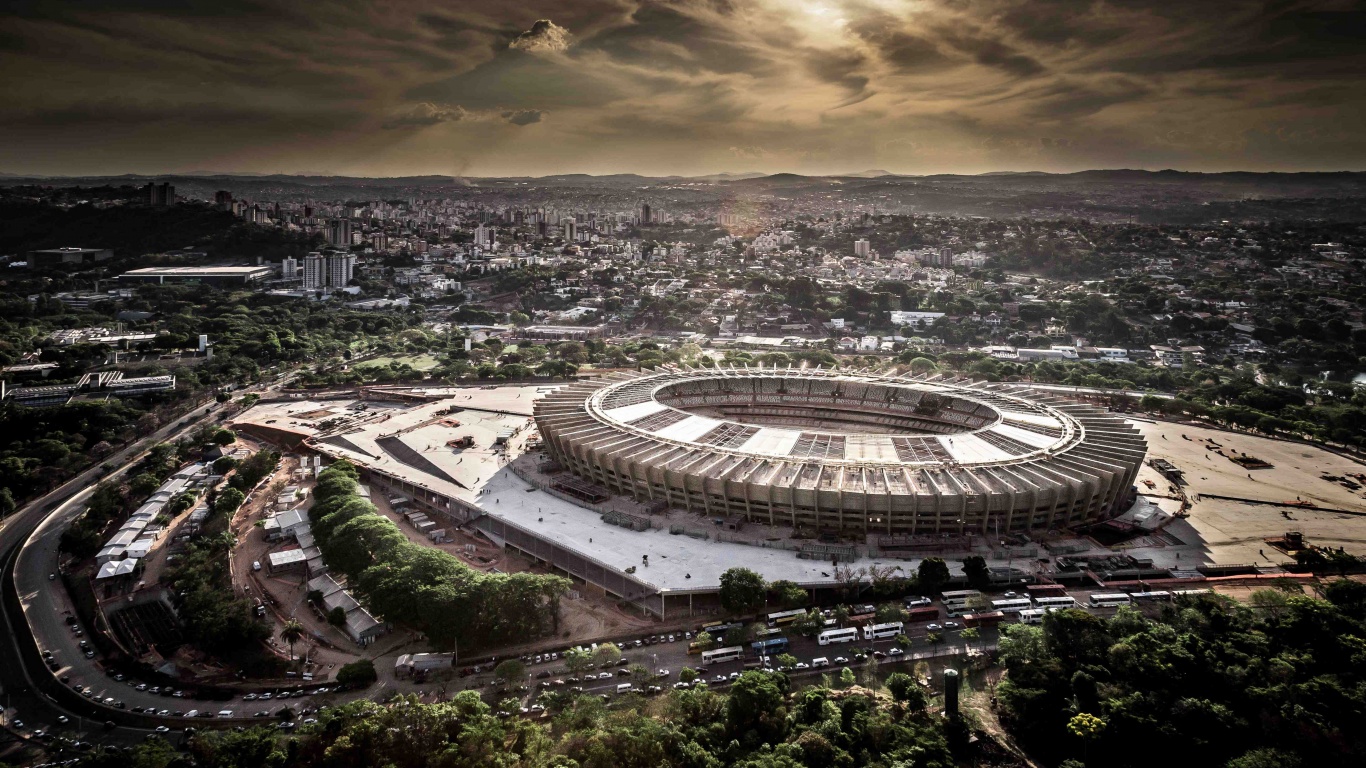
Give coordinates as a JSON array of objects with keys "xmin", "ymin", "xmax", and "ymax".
[{"xmin": 0, "ymin": 0, "xmax": 1366, "ymax": 176}]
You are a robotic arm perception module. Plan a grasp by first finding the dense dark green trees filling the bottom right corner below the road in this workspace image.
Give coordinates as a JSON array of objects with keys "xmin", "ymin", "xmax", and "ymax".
[{"xmin": 996, "ymin": 581, "xmax": 1366, "ymax": 768}]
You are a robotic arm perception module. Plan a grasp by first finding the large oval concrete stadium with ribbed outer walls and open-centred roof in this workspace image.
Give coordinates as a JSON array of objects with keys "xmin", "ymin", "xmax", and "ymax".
[{"xmin": 534, "ymin": 368, "xmax": 1146, "ymax": 536}]
